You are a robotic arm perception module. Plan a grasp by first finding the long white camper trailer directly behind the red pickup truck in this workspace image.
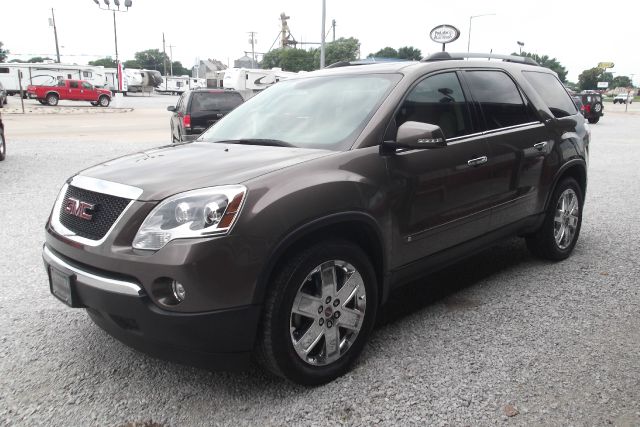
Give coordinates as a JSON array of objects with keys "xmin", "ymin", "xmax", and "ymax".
[{"xmin": 0, "ymin": 62, "xmax": 105, "ymax": 95}]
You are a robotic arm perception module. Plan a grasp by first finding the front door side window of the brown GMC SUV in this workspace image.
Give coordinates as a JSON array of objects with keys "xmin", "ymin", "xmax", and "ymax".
[{"xmin": 396, "ymin": 73, "xmax": 471, "ymax": 138}]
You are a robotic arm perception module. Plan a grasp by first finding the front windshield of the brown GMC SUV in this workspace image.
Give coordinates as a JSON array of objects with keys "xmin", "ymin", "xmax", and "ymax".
[{"xmin": 198, "ymin": 74, "xmax": 401, "ymax": 150}]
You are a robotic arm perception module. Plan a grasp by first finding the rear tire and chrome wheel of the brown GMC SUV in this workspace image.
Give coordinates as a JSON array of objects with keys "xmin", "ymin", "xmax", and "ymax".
[{"xmin": 526, "ymin": 178, "xmax": 584, "ymax": 261}]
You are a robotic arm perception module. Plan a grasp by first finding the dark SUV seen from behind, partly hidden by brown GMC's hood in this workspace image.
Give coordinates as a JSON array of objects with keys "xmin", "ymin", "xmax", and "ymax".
[{"xmin": 167, "ymin": 89, "xmax": 244, "ymax": 142}]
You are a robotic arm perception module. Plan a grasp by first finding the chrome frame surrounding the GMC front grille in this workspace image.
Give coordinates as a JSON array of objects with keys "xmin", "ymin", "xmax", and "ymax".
[{"xmin": 51, "ymin": 175, "xmax": 142, "ymax": 246}]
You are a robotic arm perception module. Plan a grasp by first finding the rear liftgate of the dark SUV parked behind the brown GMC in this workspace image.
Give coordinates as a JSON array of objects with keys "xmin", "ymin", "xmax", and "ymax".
[{"xmin": 190, "ymin": 90, "xmax": 244, "ymax": 134}]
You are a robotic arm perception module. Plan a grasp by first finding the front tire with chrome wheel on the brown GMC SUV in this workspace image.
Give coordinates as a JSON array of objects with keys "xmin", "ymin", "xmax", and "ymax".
[{"xmin": 256, "ymin": 240, "xmax": 378, "ymax": 385}]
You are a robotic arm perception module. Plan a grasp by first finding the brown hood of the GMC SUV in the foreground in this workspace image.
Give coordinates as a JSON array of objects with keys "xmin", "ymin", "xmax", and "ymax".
[{"xmin": 80, "ymin": 142, "xmax": 332, "ymax": 201}]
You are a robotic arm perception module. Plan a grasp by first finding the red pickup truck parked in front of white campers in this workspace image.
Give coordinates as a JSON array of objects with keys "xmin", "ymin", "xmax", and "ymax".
[{"xmin": 27, "ymin": 80, "xmax": 111, "ymax": 107}]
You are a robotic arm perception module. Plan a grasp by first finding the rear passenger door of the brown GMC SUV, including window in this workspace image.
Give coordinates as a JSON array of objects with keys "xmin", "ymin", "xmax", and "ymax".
[{"xmin": 463, "ymin": 69, "xmax": 553, "ymax": 230}]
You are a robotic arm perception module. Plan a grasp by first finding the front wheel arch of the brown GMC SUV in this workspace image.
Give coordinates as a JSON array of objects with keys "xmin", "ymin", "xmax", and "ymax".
[{"xmin": 254, "ymin": 212, "xmax": 389, "ymax": 310}]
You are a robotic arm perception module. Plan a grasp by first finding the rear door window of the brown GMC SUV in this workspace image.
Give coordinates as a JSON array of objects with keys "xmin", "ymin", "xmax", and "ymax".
[{"xmin": 465, "ymin": 71, "xmax": 538, "ymax": 130}]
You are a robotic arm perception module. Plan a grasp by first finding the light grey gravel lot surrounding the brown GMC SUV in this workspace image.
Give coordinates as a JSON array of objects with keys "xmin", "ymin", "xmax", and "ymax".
[{"xmin": 0, "ymin": 102, "xmax": 640, "ymax": 426}]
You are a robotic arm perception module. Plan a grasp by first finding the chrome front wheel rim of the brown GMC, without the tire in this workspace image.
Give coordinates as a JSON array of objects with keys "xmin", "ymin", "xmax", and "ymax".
[{"xmin": 290, "ymin": 260, "xmax": 367, "ymax": 366}]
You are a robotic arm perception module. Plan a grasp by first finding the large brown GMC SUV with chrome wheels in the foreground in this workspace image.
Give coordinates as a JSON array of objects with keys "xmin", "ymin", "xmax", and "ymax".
[{"xmin": 43, "ymin": 53, "xmax": 590, "ymax": 384}]
